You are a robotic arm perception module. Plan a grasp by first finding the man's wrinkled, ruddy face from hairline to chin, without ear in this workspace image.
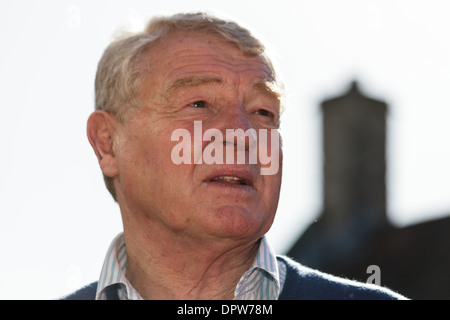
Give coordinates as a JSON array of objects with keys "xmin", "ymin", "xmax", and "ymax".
[{"xmin": 114, "ymin": 32, "xmax": 282, "ymax": 240}]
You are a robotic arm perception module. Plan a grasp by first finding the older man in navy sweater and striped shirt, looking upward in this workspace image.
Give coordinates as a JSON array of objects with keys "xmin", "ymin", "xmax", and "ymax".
[{"xmin": 67, "ymin": 13, "xmax": 402, "ymax": 299}]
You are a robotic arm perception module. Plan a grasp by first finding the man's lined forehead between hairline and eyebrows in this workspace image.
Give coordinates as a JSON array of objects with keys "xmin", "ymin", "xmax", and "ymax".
[{"xmin": 147, "ymin": 32, "xmax": 274, "ymax": 89}]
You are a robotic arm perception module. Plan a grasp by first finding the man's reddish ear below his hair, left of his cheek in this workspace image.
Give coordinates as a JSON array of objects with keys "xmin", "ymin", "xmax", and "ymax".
[{"xmin": 87, "ymin": 110, "xmax": 119, "ymax": 178}]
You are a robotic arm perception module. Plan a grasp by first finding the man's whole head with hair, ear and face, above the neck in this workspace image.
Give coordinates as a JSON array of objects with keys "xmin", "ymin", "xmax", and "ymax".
[{"xmin": 88, "ymin": 14, "xmax": 282, "ymax": 242}]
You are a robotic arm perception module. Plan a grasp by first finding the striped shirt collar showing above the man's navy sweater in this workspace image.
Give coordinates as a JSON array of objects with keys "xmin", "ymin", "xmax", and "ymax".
[{"xmin": 96, "ymin": 233, "xmax": 286, "ymax": 300}]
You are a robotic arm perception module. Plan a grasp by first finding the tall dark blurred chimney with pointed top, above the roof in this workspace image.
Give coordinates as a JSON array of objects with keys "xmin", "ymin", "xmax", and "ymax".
[{"xmin": 321, "ymin": 81, "xmax": 387, "ymax": 229}]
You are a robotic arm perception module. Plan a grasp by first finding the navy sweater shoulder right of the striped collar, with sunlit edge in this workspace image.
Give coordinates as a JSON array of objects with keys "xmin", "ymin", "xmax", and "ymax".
[{"xmin": 277, "ymin": 256, "xmax": 406, "ymax": 300}]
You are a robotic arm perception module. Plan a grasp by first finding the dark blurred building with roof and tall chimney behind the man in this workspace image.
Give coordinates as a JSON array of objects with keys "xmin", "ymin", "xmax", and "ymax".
[{"xmin": 288, "ymin": 82, "xmax": 450, "ymax": 299}]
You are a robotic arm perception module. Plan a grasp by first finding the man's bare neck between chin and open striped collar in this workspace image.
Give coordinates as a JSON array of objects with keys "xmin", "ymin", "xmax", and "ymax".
[{"xmin": 124, "ymin": 214, "xmax": 259, "ymax": 300}]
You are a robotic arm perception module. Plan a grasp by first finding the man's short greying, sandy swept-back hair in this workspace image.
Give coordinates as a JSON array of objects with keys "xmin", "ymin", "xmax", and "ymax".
[{"xmin": 95, "ymin": 13, "xmax": 281, "ymax": 201}]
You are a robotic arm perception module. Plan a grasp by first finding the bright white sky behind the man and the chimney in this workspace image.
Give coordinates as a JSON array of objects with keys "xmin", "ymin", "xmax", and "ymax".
[{"xmin": 0, "ymin": 0, "xmax": 450, "ymax": 299}]
